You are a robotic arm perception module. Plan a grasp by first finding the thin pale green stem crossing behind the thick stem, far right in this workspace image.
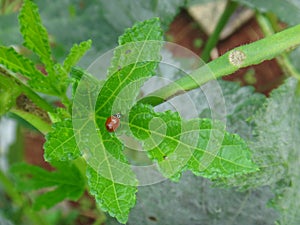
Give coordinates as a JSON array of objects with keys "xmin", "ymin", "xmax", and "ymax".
[{"xmin": 256, "ymin": 13, "xmax": 300, "ymax": 80}]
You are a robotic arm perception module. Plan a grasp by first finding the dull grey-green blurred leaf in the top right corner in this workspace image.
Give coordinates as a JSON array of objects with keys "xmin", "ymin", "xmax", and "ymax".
[{"xmin": 235, "ymin": 0, "xmax": 300, "ymax": 26}]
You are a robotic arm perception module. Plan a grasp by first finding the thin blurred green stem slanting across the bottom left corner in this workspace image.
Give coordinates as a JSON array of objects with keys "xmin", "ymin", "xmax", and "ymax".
[{"xmin": 0, "ymin": 170, "xmax": 48, "ymax": 225}]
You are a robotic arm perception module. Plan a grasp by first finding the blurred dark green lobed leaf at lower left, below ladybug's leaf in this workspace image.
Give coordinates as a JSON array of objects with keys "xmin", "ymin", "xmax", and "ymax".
[{"xmin": 10, "ymin": 163, "xmax": 85, "ymax": 210}]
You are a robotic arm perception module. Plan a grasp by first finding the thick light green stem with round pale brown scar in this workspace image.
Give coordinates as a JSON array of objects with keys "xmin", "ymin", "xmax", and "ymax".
[{"xmin": 139, "ymin": 24, "xmax": 300, "ymax": 106}]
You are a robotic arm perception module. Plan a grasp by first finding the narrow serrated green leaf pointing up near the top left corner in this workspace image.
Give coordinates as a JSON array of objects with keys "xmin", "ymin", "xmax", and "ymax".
[{"xmin": 19, "ymin": 0, "xmax": 54, "ymax": 70}]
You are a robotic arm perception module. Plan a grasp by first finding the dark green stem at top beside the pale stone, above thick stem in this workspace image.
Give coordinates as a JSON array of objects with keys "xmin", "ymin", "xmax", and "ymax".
[{"xmin": 201, "ymin": 0, "xmax": 238, "ymax": 62}]
